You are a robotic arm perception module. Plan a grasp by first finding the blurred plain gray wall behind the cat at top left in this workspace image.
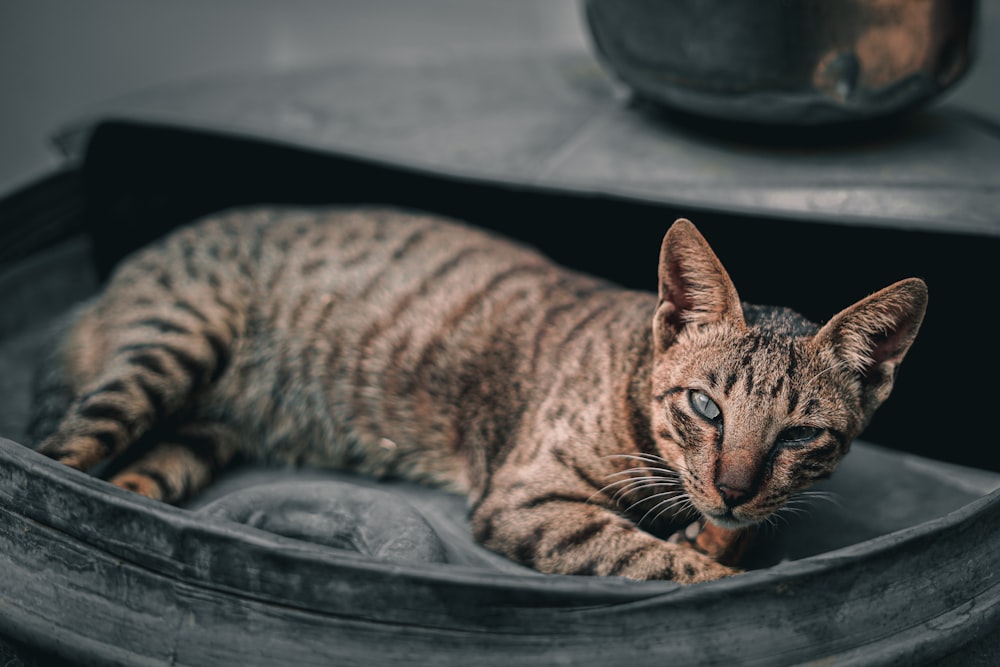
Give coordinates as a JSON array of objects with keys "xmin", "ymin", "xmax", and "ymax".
[{"xmin": 0, "ymin": 0, "xmax": 587, "ymax": 196}]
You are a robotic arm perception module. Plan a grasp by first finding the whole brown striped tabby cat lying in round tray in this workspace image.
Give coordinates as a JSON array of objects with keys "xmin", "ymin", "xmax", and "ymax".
[{"xmin": 32, "ymin": 207, "xmax": 927, "ymax": 584}]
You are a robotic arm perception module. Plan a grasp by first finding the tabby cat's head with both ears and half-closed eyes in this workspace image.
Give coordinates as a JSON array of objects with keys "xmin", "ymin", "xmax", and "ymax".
[{"xmin": 652, "ymin": 220, "xmax": 927, "ymax": 528}]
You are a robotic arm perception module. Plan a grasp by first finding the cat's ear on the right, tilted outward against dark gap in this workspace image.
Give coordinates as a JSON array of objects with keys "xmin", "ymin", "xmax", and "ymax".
[{"xmin": 815, "ymin": 278, "xmax": 927, "ymax": 417}]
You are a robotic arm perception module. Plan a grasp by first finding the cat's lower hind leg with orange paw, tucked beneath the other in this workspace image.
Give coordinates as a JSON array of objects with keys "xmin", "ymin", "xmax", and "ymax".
[{"xmin": 110, "ymin": 421, "xmax": 239, "ymax": 503}]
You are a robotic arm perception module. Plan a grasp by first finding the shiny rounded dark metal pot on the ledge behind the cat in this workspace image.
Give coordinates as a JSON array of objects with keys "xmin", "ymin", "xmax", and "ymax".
[{"xmin": 584, "ymin": 0, "xmax": 977, "ymax": 125}]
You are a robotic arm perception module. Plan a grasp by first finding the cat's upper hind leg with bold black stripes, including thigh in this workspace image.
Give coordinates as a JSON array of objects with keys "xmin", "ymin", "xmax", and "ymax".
[{"xmin": 36, "ymin": 290, "xmax": 239, "ymax": 470}]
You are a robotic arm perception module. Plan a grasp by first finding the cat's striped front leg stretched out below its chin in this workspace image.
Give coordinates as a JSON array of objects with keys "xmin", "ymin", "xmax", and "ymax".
[{"xmin": 471, "ymin": 478, "xmax": 739, "ymax": 584}]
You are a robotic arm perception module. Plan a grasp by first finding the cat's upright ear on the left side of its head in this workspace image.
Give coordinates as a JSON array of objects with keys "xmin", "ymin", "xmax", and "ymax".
[{"xmin": 653, "ymin": 218, "xmax": 744, "ymax": 350}]
